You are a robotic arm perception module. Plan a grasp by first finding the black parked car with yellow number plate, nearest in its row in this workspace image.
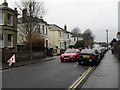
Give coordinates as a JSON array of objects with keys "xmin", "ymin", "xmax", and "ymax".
[{"xmin": 78, "ymin": 49, "xmax": 101, "ymax": 65}]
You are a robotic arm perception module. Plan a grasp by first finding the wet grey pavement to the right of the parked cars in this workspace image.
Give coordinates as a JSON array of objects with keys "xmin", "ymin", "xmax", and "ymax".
[{"xmin": 82, "ymin": 51, "xmax": 120, "ymax": 88}]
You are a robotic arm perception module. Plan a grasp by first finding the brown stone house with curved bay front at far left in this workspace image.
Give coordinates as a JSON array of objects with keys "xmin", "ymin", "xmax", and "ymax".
[{"xmin": 0, "ymin": 1, "xmax": 18, "ymax": 51}]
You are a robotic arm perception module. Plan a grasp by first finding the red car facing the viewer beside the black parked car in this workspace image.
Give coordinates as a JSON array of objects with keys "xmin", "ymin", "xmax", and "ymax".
[{"xmin": 60, "ymin": 49, "xmax": 80, "ymax": 62}]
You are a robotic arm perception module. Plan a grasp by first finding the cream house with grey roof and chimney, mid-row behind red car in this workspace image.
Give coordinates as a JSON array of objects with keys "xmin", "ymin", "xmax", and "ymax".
[{"xmin": 48, "ymin": 24, "xmax": 70, "ymax": 49}]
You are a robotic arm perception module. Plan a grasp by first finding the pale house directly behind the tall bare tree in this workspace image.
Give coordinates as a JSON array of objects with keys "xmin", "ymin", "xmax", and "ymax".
[{"xmin": 17, "ymin": 9, "xmax": 49, "ymax": 47}]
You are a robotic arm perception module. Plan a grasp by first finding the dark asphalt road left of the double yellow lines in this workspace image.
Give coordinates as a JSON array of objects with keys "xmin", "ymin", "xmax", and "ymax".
[{"xmin": 2, "ymin": 56, "xmax": 89, "ymax": 88}]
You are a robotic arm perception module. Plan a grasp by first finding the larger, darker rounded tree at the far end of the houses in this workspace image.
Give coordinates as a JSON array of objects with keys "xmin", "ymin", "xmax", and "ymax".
[{"xmin": 83, "ymin": 29, "xmax": 95, "ymax": 48}]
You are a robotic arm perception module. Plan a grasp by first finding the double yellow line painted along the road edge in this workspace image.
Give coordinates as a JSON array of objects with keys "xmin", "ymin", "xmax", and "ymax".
[{"xmin": 68, "ymin": 67, "xmax": 93, "ymax": 90}]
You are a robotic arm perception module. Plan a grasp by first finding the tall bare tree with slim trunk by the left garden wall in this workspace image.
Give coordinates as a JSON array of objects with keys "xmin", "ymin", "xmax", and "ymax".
[{"xmin": 17, "ymin": 0, "xmax": 45, "ymax": 59}]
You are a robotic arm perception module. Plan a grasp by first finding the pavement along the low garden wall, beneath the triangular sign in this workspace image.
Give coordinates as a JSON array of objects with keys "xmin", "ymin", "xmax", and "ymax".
[{"xmin": 0, "ymin": 56, "xmax": 56, "ymax": 70}]
